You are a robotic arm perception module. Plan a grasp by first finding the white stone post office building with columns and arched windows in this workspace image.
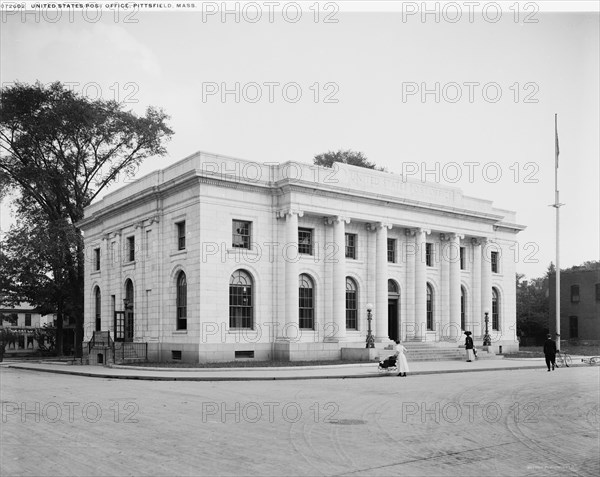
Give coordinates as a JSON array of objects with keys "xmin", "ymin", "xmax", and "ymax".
[{"xmin": 80, "ymin": 152, "xmax": 524, "ymax": 362}]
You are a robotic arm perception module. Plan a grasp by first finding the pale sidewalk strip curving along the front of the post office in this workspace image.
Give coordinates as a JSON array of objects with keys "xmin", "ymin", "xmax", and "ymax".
[{"xmin": 0, "ymin": 356, "xmax": 588, "ymax": 381}]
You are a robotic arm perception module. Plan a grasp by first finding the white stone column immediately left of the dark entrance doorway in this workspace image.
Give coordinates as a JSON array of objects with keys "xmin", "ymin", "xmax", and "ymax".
[{"xmin": 375, "ymin": 222, "xmax": 392, "ymax": 342}]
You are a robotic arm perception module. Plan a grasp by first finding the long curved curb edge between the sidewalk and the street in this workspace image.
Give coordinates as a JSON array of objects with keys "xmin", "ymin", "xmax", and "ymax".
[{"xmin": 3, "ymin": 363, "xmax": 589, "ymax": 381}]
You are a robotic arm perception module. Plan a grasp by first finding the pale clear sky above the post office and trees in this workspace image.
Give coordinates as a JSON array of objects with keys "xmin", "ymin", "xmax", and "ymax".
[{"xmin": 0, "ymin": 1, "xmax": 600, "ymax": 278}]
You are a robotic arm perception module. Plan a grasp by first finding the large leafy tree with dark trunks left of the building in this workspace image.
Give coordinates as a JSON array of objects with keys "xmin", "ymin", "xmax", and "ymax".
[{"xmin": 0, "ymin": 82, "xmax": 173, "ymax": 356}]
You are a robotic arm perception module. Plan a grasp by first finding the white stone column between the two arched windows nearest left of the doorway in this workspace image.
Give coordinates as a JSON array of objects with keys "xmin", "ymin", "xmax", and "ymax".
[{"xmin": 326, "ymin": 216, "xmax": 350, "ymax": 341}]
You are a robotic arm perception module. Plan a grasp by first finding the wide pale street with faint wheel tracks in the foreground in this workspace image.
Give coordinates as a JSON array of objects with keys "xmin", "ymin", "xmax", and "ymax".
[{"xmin": 0, "ymin": 367, "xmax": 600, "ymax": 476}]
